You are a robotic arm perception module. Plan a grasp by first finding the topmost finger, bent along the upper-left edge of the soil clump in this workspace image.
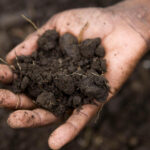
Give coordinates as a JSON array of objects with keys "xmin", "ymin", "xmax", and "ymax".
[{"xmin": 6, "ymin": 17, "xmax": 55, "ymax": 64}]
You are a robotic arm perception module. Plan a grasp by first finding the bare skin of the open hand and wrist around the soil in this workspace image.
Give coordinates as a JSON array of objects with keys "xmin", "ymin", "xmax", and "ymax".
[{"xmin": 0, "ymin": 0, "xmax": 150, "ymax": 149}]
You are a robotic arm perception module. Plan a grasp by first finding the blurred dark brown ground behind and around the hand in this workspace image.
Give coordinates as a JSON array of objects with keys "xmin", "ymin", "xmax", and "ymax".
[{"xmin": 0, "ymin": 0, "xmax": 150, "ymax": 150}]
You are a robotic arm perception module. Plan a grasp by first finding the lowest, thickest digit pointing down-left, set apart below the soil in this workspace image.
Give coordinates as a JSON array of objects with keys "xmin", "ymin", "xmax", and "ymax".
[{"xmin": 48, "ymin": 105, "xmax": 102, "ymax": 149}]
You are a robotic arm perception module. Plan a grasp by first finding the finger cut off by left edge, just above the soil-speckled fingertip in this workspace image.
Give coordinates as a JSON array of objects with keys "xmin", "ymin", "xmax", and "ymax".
[{"xmin": 0, "ymin": 89, "xmax": 35, "ymax": 109}]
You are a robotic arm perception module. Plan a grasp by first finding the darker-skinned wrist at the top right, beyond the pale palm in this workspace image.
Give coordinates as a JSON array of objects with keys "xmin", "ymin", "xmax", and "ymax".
[{"xmin": 108, "ymin": 0, "xmax": 150, "ymax": 47}]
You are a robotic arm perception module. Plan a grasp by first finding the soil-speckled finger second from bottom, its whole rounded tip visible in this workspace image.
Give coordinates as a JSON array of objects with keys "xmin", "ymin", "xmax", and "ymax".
[{"xmin": 7, "ymin": 109, "xmax": 57, "ymax": 128}]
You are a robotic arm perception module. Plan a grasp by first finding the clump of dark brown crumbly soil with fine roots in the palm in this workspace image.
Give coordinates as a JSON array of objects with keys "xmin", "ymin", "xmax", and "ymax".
[{"xmin": 11, "ymin": 30, "xmax": 109, "ymax": 116}]
